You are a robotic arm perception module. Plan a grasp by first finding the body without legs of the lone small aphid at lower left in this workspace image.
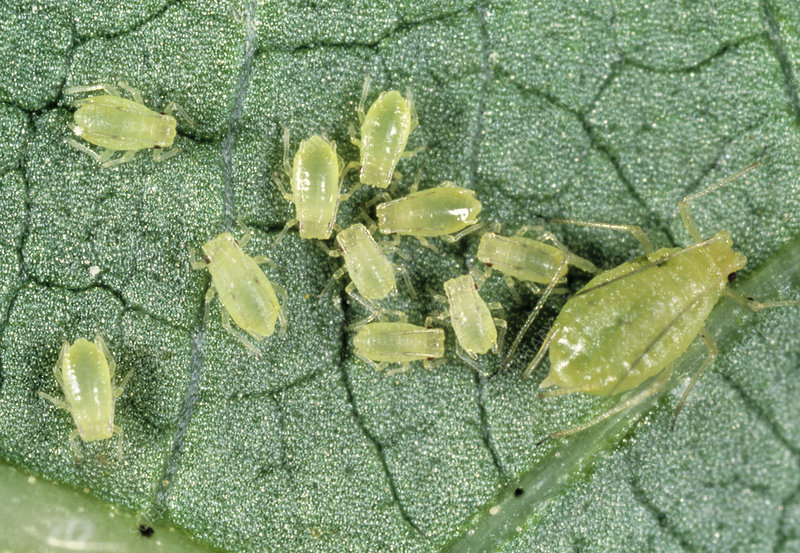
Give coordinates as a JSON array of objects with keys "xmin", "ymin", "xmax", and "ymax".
[{"xmin": 61, "ymin": 338, "xmax": 114, "ymax": 442}]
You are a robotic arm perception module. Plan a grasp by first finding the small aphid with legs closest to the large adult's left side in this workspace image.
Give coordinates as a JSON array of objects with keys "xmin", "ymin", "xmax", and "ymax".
[{"xmin": 477, "ymin": 224, "xmax": 600, "ymax": 366}]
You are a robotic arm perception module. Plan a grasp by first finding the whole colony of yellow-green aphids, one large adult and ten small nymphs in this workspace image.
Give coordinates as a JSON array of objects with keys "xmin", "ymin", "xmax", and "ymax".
[{"xmin": 39, "ymin": 80, "xmax": 800, "ymax": 458}]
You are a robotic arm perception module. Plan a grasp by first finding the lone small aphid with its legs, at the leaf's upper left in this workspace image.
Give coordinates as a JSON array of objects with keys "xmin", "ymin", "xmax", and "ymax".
[{"xmin": 64, "ymin": 81, "xmax": 188, "ymax": 168}]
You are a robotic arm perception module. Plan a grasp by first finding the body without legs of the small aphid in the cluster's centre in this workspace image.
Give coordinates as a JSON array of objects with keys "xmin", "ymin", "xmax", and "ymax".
[{"xmin": 336, "ymin": 223, "xmax": 397, "ymax": 300}]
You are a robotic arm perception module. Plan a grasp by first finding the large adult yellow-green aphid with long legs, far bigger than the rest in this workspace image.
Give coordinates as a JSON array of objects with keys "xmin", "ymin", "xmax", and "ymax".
[{"xmin": 523, "ymin": 161, "xmax": 800, "ymax": 437}]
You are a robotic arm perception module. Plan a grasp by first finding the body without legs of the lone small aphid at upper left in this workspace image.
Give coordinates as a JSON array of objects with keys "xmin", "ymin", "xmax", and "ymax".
[{"xmin": 75, "ymin": 96, "xmax": 176, "ymax": 150}]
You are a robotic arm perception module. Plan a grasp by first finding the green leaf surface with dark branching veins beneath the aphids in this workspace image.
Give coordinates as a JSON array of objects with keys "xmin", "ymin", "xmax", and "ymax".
[{"xmin": 0, "ymin": 0, "xmax": 800, "ymax": 553}]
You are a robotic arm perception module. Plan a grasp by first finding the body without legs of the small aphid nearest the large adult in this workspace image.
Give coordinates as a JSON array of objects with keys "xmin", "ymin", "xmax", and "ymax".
[{"xmin": 477, "ymin": 232, "xmax": 566, "ymax": 284}]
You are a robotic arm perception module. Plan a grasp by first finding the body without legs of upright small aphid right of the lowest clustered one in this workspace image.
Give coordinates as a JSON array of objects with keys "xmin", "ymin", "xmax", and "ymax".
[{"xmin": 444, "ymin": 275, "xmax": 497, "ymax": 355}]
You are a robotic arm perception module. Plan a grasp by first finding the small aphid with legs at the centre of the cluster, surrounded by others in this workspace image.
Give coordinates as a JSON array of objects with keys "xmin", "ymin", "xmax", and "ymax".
[{"xmin": 320, "ymin": 223, "xmax": 413, "ymax": 324}]
